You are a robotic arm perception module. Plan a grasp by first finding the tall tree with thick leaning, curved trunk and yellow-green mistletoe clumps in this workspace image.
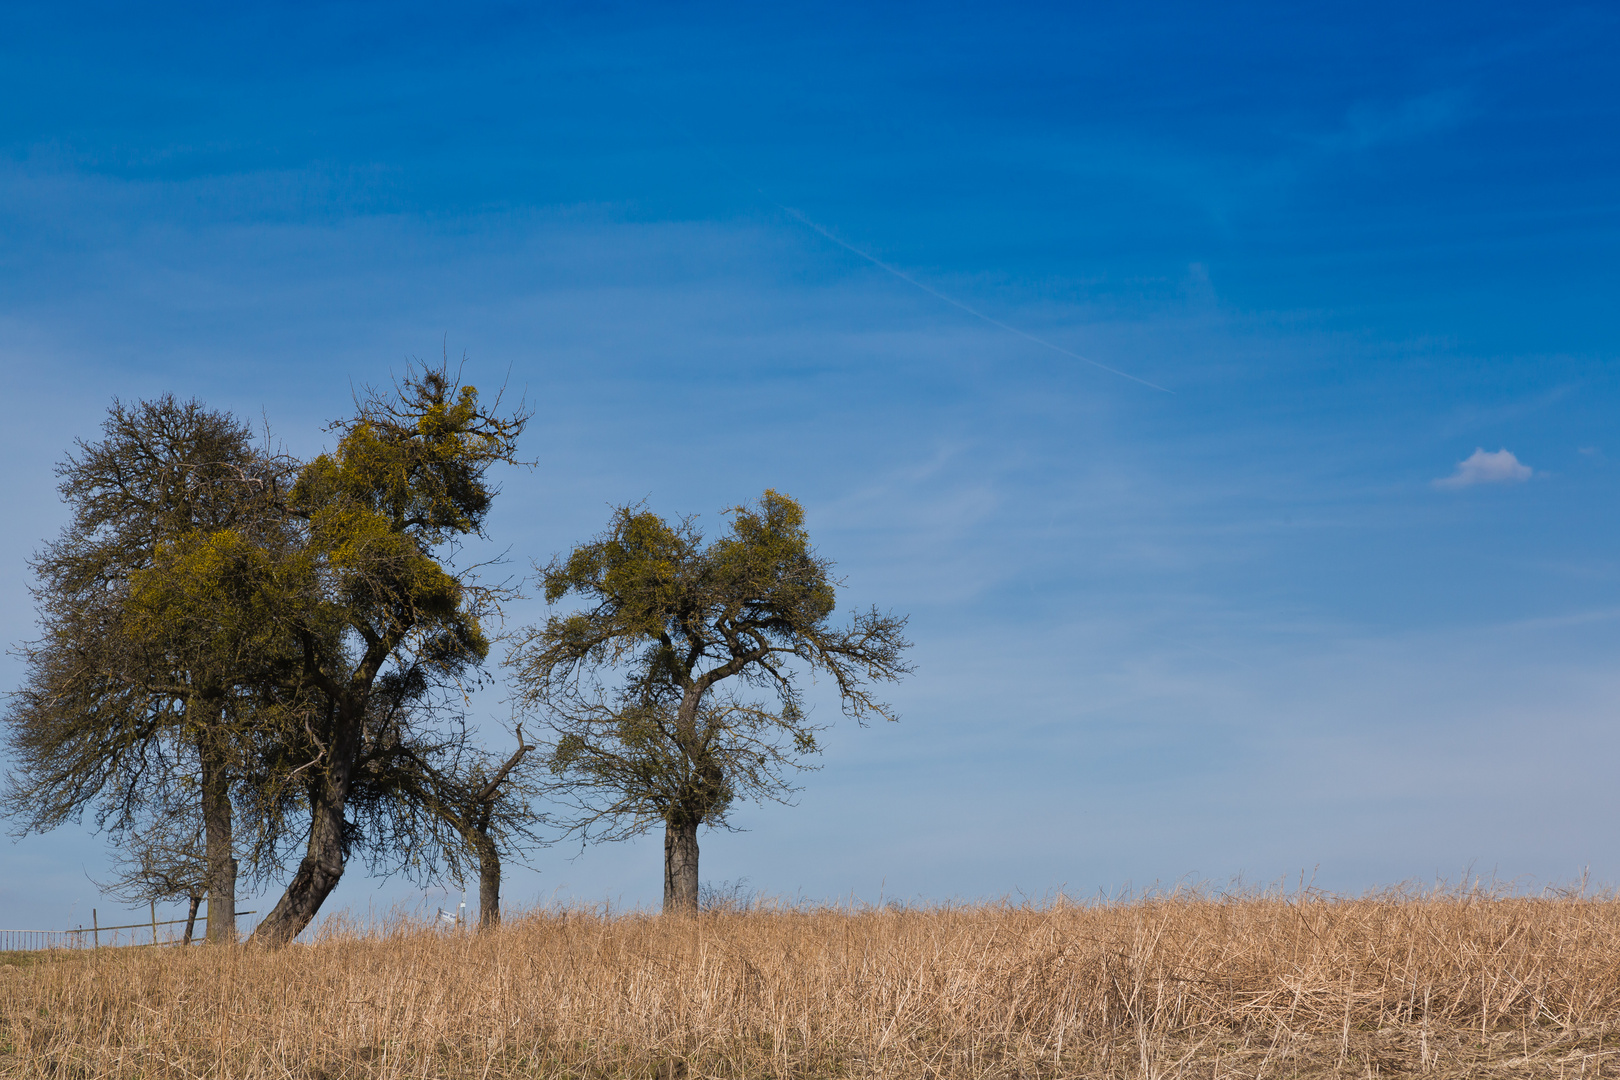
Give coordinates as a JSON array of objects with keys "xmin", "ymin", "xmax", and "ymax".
[{"xmin": 253, "ymin": 366, "xmax": 527, "ymax": 946}]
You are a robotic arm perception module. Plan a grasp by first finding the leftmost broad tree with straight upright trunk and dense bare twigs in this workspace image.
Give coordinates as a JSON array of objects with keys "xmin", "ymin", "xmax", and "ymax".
[{"xmin": 3, "ymin": 395, "xmax": 292, "ymax": 942}]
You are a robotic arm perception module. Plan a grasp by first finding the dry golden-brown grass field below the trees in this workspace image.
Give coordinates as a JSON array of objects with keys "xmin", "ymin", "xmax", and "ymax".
[{"xmin": 0, "ymin": 892, "xmax": 1620, "ymax": 1080}]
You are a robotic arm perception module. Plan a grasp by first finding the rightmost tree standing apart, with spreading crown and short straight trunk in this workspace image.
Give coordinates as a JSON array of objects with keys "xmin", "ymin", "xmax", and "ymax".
[{"xmin": 507, "ymin": 491, "xmax": 910, "ymax": 913}]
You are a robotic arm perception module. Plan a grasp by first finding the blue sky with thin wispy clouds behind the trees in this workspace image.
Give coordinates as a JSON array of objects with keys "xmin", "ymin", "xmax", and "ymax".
[{"xmin": 0, "ymin": 3, "xmax": 1620, "ymax": 926}]
